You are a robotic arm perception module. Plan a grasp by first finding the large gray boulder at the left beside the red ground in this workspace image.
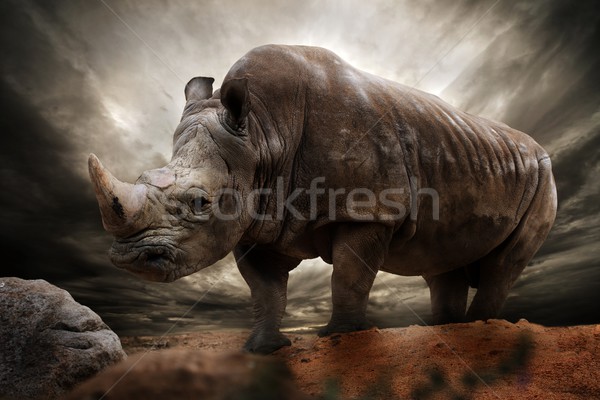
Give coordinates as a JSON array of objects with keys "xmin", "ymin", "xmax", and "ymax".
[{"xmin": 0, "ymin": 278, "xmax": 126, "ymax": 399}]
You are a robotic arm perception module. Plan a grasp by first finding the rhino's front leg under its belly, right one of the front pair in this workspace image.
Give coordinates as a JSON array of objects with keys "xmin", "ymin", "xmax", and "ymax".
[{"xmin": 319, "ymin": 223, "xmax": 392, "ymax": 336}]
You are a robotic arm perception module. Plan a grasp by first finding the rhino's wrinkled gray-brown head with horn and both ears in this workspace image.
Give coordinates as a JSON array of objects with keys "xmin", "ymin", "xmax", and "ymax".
[{"xmin": 89, "ymin": 77, "xmax": 255, "ymax": 282}]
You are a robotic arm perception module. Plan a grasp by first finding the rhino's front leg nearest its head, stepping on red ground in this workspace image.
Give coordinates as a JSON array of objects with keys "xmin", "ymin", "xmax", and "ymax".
[{"xmin": 233, "ymin": 246, "xmax": 300, "ymax": 354}]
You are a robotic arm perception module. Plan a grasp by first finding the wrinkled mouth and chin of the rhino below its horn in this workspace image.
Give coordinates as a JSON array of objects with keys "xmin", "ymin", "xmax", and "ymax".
[{"xmin": 109, "ymin": 238, "xmax": 177, "ymax": 282}]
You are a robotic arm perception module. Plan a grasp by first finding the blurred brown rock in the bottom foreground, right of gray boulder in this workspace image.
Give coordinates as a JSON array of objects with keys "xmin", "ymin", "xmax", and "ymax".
[{"xmin": 66, "ymin": 349, "xmax": 307, "ymax": 400}]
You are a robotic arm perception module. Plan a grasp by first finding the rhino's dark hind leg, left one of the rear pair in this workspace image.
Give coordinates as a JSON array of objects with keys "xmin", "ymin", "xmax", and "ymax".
[{"xmin": 425, "ymin": 268, "xmax": 469, "ymax": 325}]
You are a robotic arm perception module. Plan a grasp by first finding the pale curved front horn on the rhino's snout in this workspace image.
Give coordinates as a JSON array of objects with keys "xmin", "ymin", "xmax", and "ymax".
[{"xmin": 88, "ymin": 154, "xmax": 148, "ymax": 236}]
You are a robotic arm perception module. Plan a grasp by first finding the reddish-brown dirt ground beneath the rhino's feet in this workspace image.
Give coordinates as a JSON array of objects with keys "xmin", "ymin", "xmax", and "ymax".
[{"xmin": 121, "ymin": 320, "xmax": 600, "ymax": 399}]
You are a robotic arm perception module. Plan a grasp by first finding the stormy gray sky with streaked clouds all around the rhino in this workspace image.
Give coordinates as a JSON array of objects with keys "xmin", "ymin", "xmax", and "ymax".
[{"xmin": 0, "ymin": 0, "xmax": 600, "ymax": 335}]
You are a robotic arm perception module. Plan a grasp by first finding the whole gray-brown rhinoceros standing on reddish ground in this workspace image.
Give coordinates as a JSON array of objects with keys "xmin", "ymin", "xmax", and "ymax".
[{"xmin": 89, "ymin": 45, "xmax": 557, "ymax": 353}]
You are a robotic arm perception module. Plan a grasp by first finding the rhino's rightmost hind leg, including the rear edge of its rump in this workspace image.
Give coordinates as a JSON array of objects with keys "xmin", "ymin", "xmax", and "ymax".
[{"xmin": 466, "ymin": 158, "xmax": 556, "ymax": 321}]
